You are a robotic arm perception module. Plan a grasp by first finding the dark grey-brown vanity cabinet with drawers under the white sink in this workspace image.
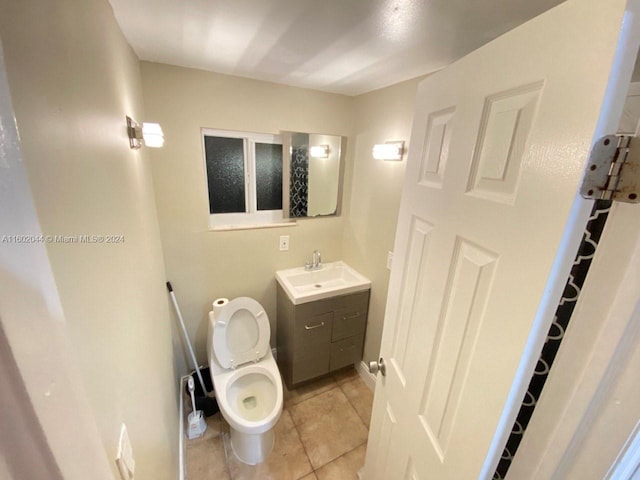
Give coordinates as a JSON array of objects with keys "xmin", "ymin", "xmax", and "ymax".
[{"xmin": 276, "ymin": 284, "xmax": 369, "ymax": 388}]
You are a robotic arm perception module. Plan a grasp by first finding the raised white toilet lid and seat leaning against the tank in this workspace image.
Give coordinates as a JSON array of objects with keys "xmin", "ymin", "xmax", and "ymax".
[{"xmin": 213, "ymin": 297, "xmax": 271, "ymax": 368}]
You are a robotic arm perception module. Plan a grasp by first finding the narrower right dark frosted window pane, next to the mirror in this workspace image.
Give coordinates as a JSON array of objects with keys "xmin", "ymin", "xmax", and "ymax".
[{"xmin": 256, "ymin": 143, "xmax": 282, "ymax": 210}]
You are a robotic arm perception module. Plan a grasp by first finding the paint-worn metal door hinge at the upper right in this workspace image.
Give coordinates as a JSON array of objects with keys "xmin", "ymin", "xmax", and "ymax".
[{"xmin": 580, "ymin": 135, "xmax": 640, "ymax": 203}]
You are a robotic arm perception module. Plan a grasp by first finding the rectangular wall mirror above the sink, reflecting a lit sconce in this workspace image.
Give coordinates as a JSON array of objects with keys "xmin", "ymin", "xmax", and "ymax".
[{"xmin": 282, "ymin": 132, "xmax": 347, "ymax": 218}]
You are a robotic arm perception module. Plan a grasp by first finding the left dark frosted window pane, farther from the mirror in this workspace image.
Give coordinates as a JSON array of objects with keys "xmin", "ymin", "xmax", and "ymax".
[{"xmin": 204, "ymin": 135, "xmax": 246, "ymax": 214}]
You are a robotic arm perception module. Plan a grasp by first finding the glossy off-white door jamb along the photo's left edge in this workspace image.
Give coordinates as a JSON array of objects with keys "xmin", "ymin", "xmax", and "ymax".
[{"xmin": 0, "ymin": 42, "xmax": 113, "ymax": 480}]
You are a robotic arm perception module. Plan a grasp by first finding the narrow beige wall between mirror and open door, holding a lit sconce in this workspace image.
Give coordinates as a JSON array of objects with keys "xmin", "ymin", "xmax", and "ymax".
[{"xmin": 343, "ymin": 79, "xmax": 420, "ymax": 362}]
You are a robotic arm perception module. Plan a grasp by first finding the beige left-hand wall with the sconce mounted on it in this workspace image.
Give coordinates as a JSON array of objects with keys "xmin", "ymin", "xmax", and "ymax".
[{"xmin": 0, "ymin": 0, "xmax": 178, "ymax": 480}]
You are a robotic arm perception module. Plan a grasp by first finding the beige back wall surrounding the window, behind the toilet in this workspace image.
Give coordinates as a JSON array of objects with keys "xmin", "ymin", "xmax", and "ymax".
[{"xmin": 142, "ymin": 62, "xmax": 353, "ymax": 371}]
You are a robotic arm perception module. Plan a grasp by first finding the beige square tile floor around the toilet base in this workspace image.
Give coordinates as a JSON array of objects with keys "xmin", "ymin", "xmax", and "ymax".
[{"xmin": 185, "ymin": 368, "xmax": 373, "ymax": 480}]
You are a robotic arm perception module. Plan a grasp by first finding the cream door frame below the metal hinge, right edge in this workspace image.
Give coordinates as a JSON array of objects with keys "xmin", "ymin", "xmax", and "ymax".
[{"xmin": 507, "ymin": 199, "xmax": 640, "ymax": 480}]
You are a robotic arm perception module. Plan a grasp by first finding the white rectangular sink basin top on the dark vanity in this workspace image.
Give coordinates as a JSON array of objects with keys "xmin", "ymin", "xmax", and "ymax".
[{"xmin": 276, "ymin": 261, "xmax": 371, "ymax": 305}]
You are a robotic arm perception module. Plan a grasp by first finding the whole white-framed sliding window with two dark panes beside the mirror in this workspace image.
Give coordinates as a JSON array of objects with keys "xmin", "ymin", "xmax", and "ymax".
[{"xmin": 202, "ymin": 129, "xmax": 283, "ymax": 228}]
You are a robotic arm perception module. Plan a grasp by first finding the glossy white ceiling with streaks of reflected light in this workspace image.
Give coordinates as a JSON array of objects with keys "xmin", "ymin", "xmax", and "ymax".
[{"xmin": 110, "ymin": 0, "xmax": 562, "ymax": 95}]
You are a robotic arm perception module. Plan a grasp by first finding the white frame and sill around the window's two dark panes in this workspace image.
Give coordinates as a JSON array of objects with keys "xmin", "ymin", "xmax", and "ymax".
[{"xmin": 200, "ymin": 128, "xmax": 293, "ymax": 230}]
